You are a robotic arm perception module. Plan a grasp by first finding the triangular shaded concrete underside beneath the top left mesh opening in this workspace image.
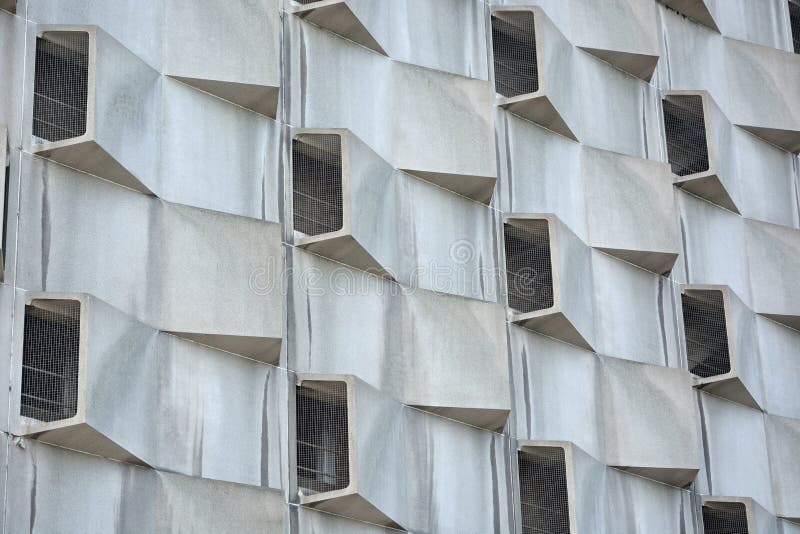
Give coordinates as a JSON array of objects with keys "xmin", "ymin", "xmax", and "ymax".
[{"xmin": 33, "ymin": 140, "xmax": 155, "ymax": 195}]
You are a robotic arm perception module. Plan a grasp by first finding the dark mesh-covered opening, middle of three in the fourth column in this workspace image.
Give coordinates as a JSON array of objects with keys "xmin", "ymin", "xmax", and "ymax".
[{"xmin": 681, "ymin": 290, "xmax": 731, "ymax": 378}]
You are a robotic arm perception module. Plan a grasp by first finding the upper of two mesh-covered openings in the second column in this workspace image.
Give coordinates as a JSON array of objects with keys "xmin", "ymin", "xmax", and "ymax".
[{"xmin": 292, "ymin": 134, "xmax": 343, "ymax": 235}]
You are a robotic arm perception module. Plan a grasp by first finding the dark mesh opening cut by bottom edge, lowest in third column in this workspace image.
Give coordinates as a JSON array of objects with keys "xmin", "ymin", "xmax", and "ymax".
[{"xmin": 517, "ymin": 447, "xmax": 570, "ymax": 534}]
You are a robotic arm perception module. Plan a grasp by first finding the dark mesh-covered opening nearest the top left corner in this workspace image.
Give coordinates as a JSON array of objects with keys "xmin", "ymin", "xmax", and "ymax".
[{"xmin": 33, "ymin": 32, "xmax": 89, "ymax": 141}]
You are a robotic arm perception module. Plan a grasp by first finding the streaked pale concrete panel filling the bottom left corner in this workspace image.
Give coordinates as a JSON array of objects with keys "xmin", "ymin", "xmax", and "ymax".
[{"xmin": 2, "ymin": 440, "xmax": 284, "ymax": 534}]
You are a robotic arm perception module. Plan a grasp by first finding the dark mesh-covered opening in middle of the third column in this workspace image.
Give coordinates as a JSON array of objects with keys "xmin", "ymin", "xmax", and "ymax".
[{"xmin": 503, "ymin": 219, "xmax": 553, "ymax": 313}]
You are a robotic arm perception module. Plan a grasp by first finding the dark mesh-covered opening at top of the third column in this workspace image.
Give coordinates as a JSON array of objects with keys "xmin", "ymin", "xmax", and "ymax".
[{"xmin": 492, "ymin": 11, "xmax": 539, "ymax": 97}]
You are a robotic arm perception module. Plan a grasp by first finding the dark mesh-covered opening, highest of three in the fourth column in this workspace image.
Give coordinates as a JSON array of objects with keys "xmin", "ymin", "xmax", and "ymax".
[{"xmin": 662, "ymin": 95, "xmax": 709, "ymax": 176}]
